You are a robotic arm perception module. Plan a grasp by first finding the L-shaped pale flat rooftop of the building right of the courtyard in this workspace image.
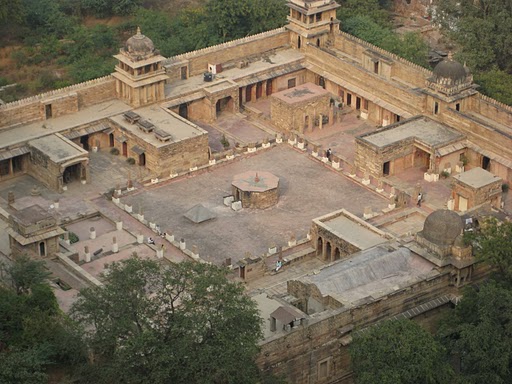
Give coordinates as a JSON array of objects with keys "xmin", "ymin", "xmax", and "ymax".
[{"xmin": 360, "ymin": 118, "xmax": 464, "ymax": 148}]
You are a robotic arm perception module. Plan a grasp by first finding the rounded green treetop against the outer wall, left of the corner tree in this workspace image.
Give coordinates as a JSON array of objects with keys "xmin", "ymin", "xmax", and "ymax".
[{"xmin": 349, "ymin": 319, "xmax": 454, "ymax": 384}]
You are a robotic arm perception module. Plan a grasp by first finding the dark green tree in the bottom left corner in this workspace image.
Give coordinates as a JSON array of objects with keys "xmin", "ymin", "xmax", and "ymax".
[{"xmin": 0, "ymin": 257, "xmax": 85, "ymax": 384}]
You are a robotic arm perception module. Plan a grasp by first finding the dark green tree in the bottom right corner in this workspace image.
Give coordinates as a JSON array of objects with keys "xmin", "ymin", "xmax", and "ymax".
[{"xmin": 438, "ymin": 281, "xmax": 512, "ymax": 384}]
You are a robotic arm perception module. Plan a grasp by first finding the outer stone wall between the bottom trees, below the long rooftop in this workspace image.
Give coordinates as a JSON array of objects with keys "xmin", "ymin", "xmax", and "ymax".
[{"xmin": 257, "ymin": 272, "xmax": 453, "ymax": 384}]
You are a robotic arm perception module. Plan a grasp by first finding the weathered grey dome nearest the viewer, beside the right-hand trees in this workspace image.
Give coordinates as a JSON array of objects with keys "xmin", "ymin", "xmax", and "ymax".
[{"xmin": 421, "ymin": 209, "xmax": 464, "ymax": 245}]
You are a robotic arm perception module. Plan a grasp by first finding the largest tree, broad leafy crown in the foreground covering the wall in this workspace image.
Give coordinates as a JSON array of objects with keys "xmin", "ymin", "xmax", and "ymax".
[{"xmin": 72, "ymin": 255, "xmax": 261, "ymax": 383}]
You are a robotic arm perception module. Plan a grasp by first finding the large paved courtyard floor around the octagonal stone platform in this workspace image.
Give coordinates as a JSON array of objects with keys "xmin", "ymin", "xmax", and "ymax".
[{"xmin": 123, "ymin": 145, "xmax": 388, "ymax": 263}]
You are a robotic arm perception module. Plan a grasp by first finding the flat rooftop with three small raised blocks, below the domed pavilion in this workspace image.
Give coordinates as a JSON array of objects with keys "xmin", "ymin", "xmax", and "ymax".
[{"xmin": 110, "ymin": 104, "xmax": 207, "ymax": 147}]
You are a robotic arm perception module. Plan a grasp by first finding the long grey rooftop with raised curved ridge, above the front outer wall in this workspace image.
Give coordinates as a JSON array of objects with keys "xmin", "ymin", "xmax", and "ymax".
[{"xmin": 299, "ymin": 245, "xmax": 436, "ymax": 306}]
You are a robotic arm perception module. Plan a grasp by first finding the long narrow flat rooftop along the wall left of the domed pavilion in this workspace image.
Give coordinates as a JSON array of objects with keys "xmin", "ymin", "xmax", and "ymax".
[{"xmin": 0, "ymin": 99, "xmax": 132, "ymax": 148}]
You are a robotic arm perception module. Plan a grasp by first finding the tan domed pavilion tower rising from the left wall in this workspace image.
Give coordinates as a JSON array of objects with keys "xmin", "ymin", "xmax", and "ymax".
[{"xmin": 112, "ymin": 28, "xmax": 168, "ymax": 107}]
